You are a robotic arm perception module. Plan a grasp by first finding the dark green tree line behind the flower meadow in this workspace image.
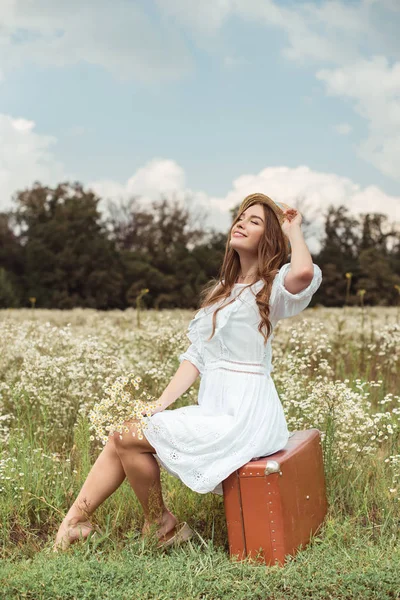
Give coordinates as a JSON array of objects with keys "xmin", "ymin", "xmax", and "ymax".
[{"xmin": 0, "ymin": 182, "xmax": 400, "ymax": 310}]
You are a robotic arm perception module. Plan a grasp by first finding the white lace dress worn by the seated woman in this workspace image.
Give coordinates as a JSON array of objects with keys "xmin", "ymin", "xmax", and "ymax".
[{"xmin": 143, "ymin": 263, "xmax": 322, "ymax": 494}]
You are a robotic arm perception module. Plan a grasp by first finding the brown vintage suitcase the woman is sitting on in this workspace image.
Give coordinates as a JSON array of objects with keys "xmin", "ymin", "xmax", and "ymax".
[{"xmin": 222, "ymin": 429, "xmax": 327, "ymax": 566}]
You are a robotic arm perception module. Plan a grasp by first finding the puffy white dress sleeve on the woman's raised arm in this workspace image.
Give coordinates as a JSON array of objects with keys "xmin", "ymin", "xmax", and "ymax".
[{"xmin": 270, "ymin": 263, "xmax": 322, "ymax": 321}]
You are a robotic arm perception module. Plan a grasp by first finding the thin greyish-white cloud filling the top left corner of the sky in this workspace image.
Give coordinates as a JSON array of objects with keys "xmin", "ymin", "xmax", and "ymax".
[{"xmin": 0, "ymin": 0, "xmax": 191, "ymax": 82}]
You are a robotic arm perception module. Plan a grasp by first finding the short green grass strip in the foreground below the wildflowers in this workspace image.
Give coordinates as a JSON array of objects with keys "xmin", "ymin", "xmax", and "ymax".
[{"xmin": 0, "ymin": 519, "xmax": 400, "ymax": 600}]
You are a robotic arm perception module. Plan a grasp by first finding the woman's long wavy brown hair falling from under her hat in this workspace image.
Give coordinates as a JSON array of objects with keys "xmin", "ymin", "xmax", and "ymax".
[{"xmin": 200, "ymin": 194, "xmax": 290, "ymax": 345}]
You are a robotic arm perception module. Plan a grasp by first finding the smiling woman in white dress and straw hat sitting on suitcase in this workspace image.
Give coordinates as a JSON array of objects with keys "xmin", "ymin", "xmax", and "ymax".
[{"xmin": 54, "ymin": 193, "xmax": 322, "ymax": 550}]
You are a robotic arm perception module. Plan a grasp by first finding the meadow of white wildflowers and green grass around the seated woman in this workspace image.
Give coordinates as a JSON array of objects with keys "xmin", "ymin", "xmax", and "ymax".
[{"xmin": 0, "ymin": 306, "xmax": 400, "ymax": 600}]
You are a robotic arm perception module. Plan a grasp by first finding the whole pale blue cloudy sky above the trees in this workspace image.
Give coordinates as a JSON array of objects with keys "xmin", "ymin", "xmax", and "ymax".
[{"xmin": 0, "ymin": 0, "xmax": 400, "ymax": 251}]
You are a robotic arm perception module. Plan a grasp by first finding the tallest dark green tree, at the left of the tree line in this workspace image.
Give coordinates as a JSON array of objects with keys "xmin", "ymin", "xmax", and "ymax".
[{"xmin": 13, "ymin": 182, "xmax": 123, "ymax": 309}]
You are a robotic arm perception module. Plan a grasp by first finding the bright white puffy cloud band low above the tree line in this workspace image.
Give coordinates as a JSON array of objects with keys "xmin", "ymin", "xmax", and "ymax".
[{"xmin": 0, "ymin": 120, "xmax": 400, "ymax": 252}]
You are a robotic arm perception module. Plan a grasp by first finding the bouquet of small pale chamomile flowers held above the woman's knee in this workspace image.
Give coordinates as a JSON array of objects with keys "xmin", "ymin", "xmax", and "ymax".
[{"xmin": 88, "ymin": 373, "xmax": 161, "ymax": 445}]
